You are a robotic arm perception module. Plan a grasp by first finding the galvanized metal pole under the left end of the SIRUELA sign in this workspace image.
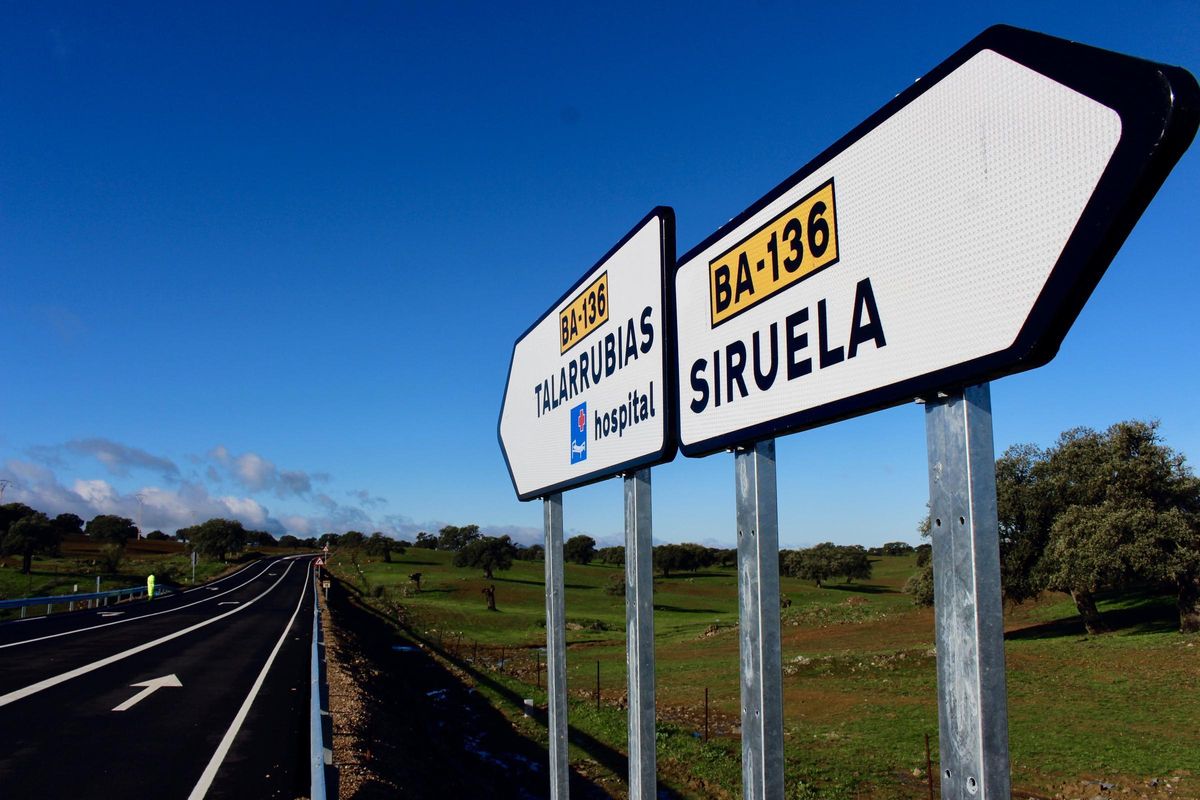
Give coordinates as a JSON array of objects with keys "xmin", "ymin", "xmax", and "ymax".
[{"xmin": 733, "ymin": 439, "xmax": 784, "ymax": 800}]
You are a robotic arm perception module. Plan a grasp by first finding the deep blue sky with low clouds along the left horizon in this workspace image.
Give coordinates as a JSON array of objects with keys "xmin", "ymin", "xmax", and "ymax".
[{"xmin": 0, "ymin": 1, "xmax": 1200, "ymax": 546}]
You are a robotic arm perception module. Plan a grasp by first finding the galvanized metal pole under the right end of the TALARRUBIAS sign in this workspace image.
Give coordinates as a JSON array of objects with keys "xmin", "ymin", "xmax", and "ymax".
[{"xmin": 625, "ymin": 468, "xmax": 658, "ymax": 800}]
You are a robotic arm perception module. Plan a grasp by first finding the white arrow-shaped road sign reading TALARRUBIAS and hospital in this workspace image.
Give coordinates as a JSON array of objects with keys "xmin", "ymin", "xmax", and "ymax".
[{"xmin": 499, "ymin": 207, "xmax": 676, "ymax": 500}]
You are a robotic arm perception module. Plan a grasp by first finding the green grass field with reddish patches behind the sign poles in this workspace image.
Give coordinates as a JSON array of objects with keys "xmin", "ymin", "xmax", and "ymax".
[{"xmin": 331, "ymin": 549, "xmax": 1200, "ymax": 799}]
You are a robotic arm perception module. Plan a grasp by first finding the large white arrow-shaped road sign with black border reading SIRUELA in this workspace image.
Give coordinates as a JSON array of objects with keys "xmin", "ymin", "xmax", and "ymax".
[{"xmin": 676, "ymin": 26, "xmax": 1200, "ymax": 456}]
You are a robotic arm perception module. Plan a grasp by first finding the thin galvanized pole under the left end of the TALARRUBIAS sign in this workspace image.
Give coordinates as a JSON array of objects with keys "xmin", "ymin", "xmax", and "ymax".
[{"xmin": 542, "ymin": 492, "xmax": 570, "ymax": 800}]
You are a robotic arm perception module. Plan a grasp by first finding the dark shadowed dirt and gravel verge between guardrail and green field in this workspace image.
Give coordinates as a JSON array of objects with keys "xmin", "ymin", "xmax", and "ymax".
[{"xmin": 325, "ymin": 579, "xmax": 610, "ymax": 800}]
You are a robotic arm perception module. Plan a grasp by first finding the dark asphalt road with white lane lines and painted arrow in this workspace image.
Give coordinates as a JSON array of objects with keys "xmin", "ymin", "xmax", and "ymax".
[{"xmin": 0, "ymin": 557, "xmax": 314, "ymax": 800}]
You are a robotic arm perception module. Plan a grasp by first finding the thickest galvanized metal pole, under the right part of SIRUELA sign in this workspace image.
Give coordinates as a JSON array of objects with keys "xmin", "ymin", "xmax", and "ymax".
[{"xmin": 925, "ymin": 384, "xmax": 1012, "ymax": 800}]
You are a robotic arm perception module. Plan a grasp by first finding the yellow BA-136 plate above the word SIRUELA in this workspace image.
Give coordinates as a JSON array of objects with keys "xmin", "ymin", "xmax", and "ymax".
[{"xmin": 708, "ymin": 179, "xmax": 838, "ymax": 327}]
